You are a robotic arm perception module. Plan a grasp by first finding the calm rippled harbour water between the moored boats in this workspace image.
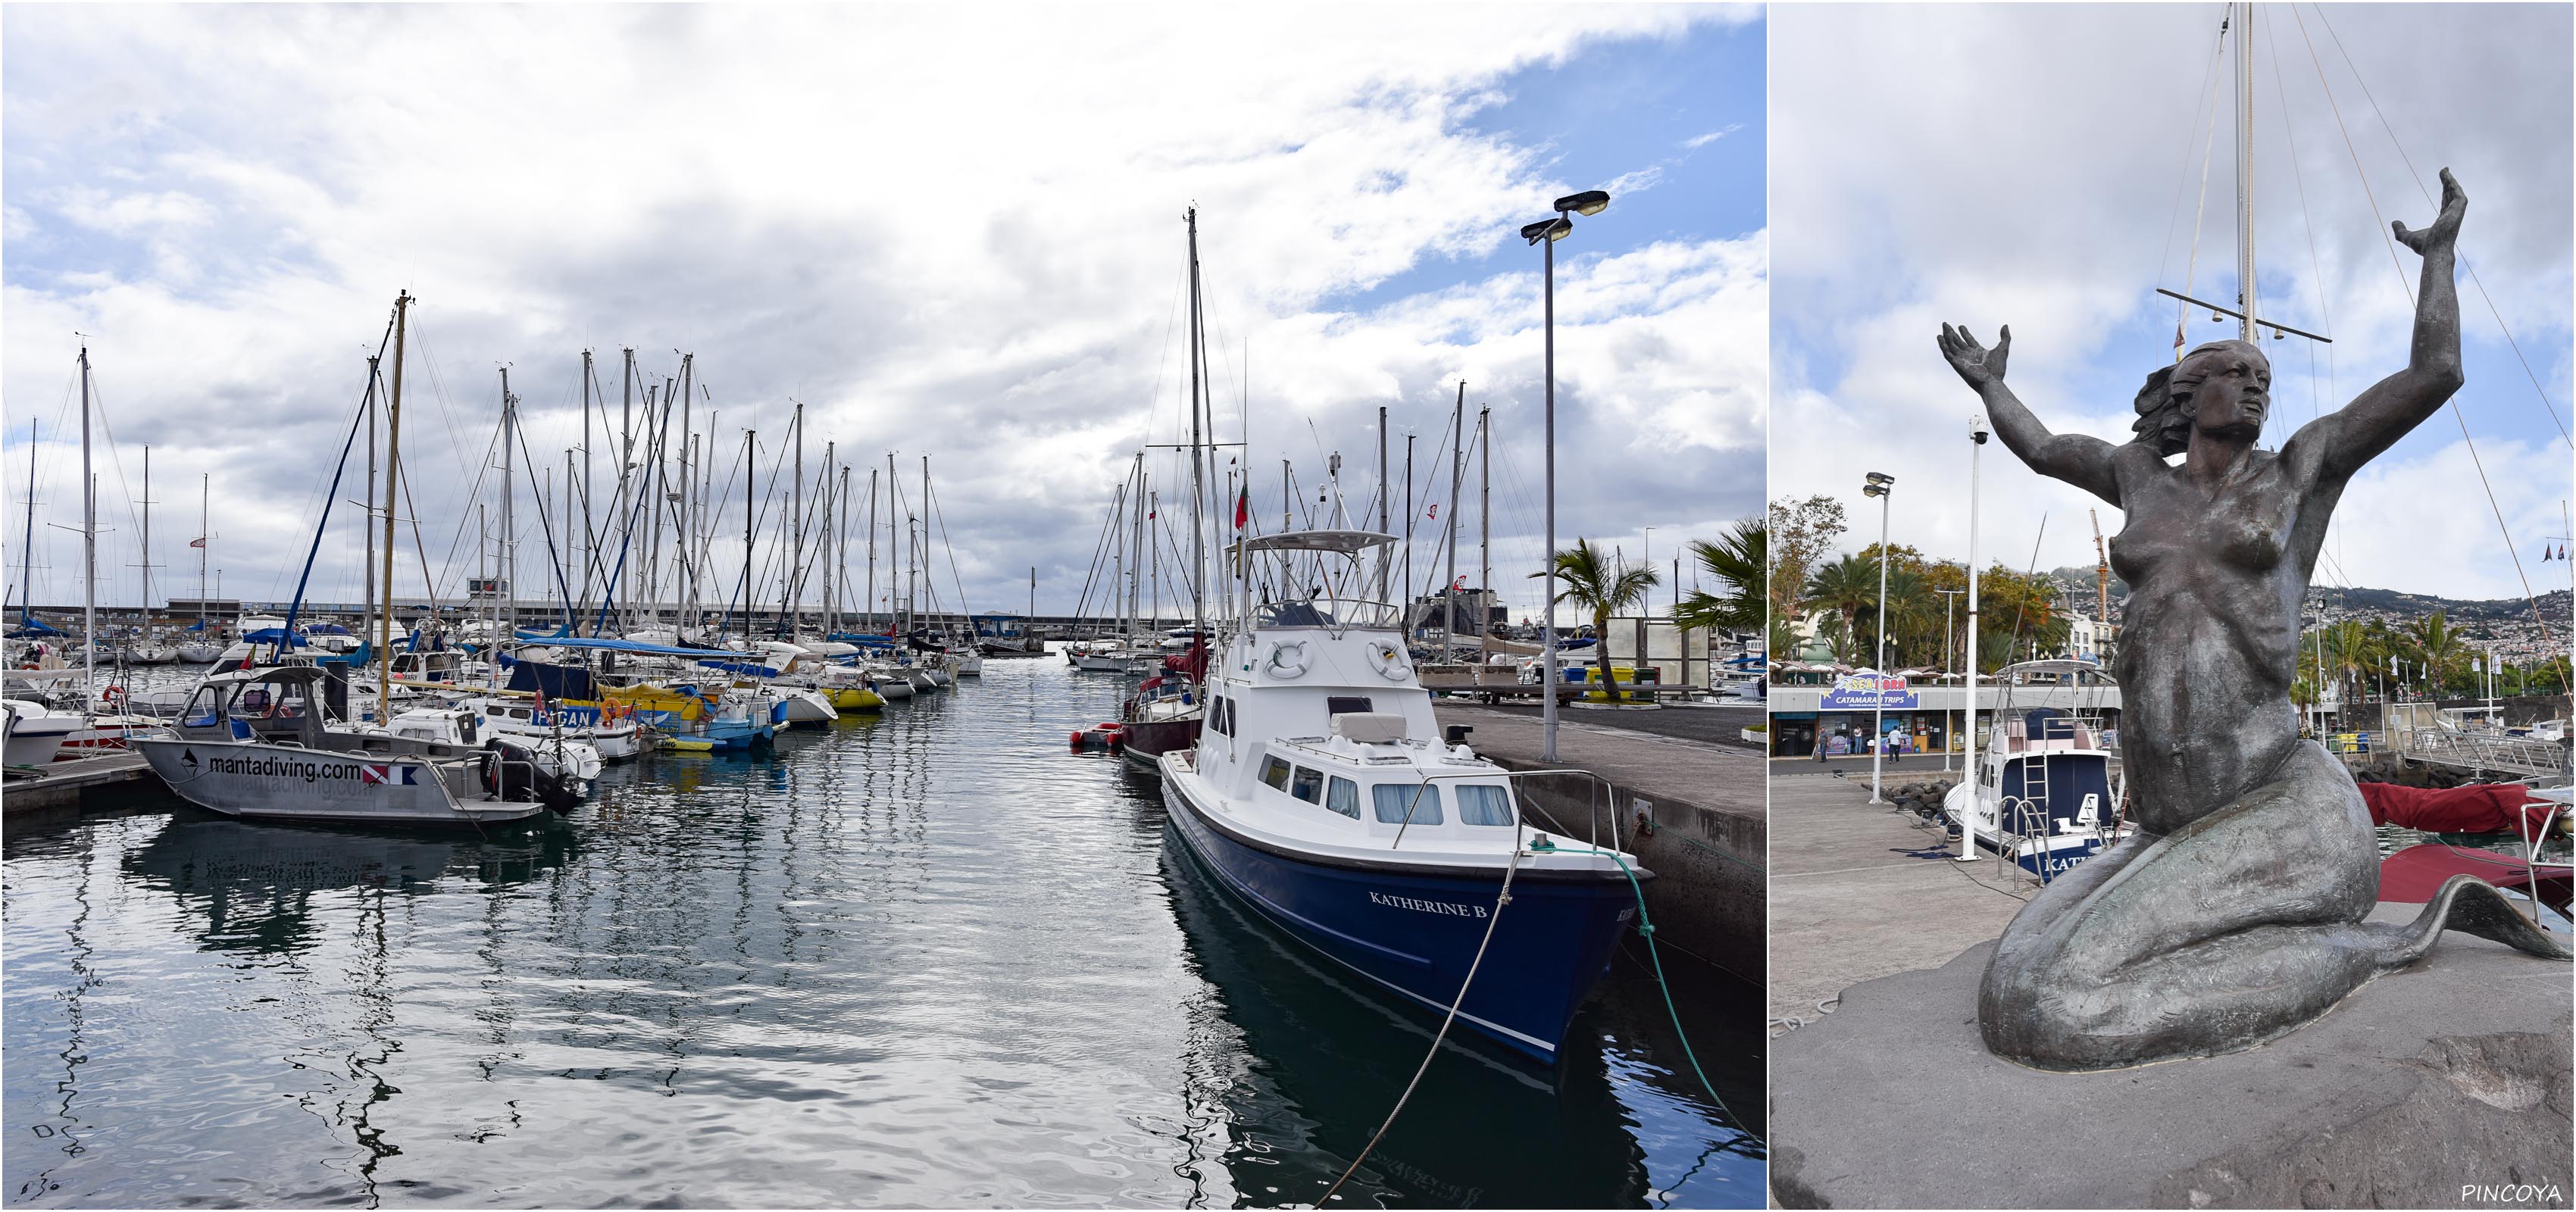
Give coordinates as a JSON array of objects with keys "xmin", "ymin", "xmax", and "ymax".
[{"xmin": 0, "ymin": 659, "xmax": 1762, "ymax": 1207}]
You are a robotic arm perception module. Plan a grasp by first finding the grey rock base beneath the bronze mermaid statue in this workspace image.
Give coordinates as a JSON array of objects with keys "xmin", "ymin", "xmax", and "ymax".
[{"xmin": 1770, "ymin": 903, "xmax": 2576, "ymax": 1207}]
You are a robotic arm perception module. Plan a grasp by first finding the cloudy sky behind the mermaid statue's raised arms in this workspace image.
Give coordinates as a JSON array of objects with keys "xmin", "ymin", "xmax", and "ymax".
[{"xmin": 1770, "ymin": 5, "xmax": 2571, "ymax": 597}]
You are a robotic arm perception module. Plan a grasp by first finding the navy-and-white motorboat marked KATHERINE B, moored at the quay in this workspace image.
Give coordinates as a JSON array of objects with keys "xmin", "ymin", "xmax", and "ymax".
[{"xmin": 1159, "ymin": 530, "xmax": 1651, "ymax": 1063}]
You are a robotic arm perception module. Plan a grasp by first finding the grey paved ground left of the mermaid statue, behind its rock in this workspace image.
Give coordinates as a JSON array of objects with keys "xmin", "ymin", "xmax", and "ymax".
[{"xmin": 1770, "ymin": 764, "xmax": 2035, "ymax": 1024}]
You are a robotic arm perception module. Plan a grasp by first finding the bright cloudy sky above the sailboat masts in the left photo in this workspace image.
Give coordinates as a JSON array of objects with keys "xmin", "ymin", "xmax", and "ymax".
[{"xmin": 0, "ymin": 5, "xmax": 1762, "ymax": 630}]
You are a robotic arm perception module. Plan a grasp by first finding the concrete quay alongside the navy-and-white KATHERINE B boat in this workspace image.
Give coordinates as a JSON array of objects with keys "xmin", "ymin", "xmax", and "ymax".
[{"xmin": 1435, "ymin": 700, "xmax": 1770, "ymax": 986}]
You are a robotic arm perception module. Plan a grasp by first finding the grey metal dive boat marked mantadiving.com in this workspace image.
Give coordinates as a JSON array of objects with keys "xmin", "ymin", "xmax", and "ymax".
[{"xmin": 134, "ymin": 667, "xmax": 546, "ymax": 826}]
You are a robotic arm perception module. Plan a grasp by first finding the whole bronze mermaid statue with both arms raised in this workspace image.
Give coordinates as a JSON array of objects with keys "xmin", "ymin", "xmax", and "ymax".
[{"xmin": 1940, "ymin": 170, "xmax": 2568, "ymax": 1070}]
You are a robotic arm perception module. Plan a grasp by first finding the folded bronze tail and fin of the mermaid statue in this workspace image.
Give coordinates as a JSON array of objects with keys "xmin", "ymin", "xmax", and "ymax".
[{"xmin": 1978, "ymin": 741, "xmax": 2568, "ymax": 1070}]
